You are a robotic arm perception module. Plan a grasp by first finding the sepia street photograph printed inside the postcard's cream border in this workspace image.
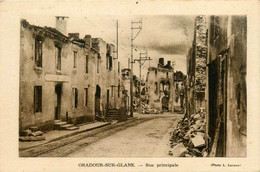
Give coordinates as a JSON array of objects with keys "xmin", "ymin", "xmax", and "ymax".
[{"xmin": 19, "ymin": 15, "xmax": 247, "ymax": 157}]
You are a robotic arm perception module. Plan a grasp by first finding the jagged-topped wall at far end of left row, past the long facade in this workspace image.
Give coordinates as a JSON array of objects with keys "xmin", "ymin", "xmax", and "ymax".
[{"xmin": 92, "ymin": 38, "xmax": 121, "ymax": 115}]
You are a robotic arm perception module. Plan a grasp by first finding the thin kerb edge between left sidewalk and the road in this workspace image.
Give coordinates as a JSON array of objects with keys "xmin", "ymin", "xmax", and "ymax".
[{"xmin": 19, "ymin": 122, "xmax": 111, "ymax": 151}]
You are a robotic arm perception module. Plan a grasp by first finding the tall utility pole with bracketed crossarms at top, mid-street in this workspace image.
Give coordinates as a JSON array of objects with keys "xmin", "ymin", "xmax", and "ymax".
[{"xmin": 130, "ymin": 19, "xmax": 142, "ymax": 117}]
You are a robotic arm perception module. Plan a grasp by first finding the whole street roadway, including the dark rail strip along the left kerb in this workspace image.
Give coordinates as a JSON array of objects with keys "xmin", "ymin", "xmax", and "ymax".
[{"xmin": 20, "ymin": 113, "xmax": 183, "ymax": 157}]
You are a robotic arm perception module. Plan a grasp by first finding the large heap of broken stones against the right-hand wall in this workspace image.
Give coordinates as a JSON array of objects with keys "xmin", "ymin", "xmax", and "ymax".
[{"xmin": 169, "ymin": 112, "xmax": 208, "ymax": 157}]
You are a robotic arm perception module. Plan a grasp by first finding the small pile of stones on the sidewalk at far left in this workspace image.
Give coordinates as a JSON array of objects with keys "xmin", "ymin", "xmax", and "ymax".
[{"xmin": 19, "ymin": 126, "xmax": 45, "ymax": 142}]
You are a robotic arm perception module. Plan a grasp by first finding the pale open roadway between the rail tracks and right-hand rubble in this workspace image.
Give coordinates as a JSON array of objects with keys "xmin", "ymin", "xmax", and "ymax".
[{"xmin": 68, "ymin": 114, "xmax": 182, "ymax": 157}]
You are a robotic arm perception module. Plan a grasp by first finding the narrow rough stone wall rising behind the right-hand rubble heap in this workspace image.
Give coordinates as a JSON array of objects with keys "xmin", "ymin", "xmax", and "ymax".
[{"xmin": 187, "ymin": 16, "xmax": 207, "ymax": 114}]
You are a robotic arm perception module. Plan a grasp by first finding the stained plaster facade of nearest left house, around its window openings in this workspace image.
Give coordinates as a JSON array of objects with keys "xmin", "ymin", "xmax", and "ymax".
[{"xmin": 20, "ymin": 20, "xmax": 97, "ymax": 130}]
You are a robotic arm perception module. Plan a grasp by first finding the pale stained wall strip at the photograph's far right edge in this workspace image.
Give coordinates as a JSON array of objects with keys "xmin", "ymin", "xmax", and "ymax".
[{"xmin": 226, "ymin": 16, "xmax": 247, "ymax": 157}]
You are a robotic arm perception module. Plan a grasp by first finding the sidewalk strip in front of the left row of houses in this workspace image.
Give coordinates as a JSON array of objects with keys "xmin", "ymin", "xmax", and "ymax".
[{"xmin": 19, "ymin": 122, "xmax": 111, "ymax": 150}]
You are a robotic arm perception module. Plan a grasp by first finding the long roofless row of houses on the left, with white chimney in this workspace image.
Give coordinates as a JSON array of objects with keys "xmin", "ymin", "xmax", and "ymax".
[{"xmin": 19, "ymin": 17, "xmax": 121, "ymax": 130}]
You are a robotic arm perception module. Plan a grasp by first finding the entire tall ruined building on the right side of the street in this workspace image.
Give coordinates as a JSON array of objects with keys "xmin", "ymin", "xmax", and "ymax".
[{"xmin": 186, "ymin": 16, "xmax": 247, "ymax": 157}]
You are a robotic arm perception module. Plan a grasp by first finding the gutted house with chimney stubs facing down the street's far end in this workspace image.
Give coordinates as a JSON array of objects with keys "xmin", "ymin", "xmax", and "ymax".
[{"xmin": 145, "ymin": 58, "xmax": 175, "ymax": 112}]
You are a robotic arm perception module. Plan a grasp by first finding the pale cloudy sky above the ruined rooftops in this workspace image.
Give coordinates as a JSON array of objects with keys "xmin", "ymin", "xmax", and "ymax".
[{"xmin": 22, "ymin": 14, "xmax": 195, "ymax": 78}]
